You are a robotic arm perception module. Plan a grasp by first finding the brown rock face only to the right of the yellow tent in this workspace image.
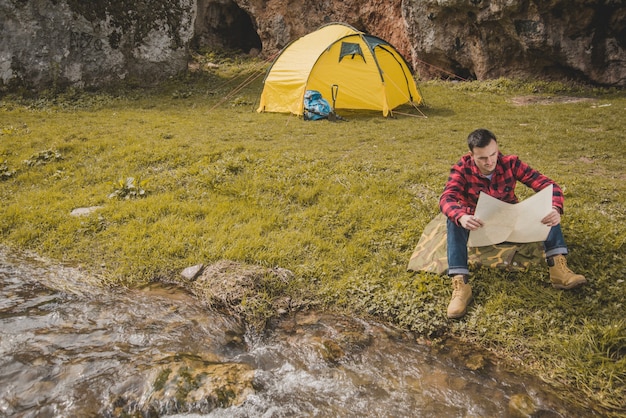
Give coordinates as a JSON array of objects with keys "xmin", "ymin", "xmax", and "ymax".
[{"xmin": 403, "ymin": 0, "xmax": 626, "ymax": 86}]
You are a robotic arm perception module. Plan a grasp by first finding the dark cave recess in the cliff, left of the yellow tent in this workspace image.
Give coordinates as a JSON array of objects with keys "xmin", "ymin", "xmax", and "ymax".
[{"xmin": 191, "ymin": 0, "xmax": 263, "ymax": 54}]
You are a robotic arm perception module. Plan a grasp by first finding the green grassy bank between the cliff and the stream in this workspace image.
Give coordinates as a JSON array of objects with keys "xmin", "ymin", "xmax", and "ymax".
[{"xmin": 0, "ymin": 57, "xmax": 626, "ymax": 416}]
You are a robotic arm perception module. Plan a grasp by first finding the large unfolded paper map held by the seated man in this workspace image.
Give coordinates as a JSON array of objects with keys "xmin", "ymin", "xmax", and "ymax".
[{"xmin": 467, "ymin": 185, "xmax": 552, "ymax": 247}]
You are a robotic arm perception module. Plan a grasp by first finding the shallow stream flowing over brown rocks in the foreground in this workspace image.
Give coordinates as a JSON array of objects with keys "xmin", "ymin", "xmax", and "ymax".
[{"xmin": 0, "ymin": 250, "xmax": 585, "ymax": 417}]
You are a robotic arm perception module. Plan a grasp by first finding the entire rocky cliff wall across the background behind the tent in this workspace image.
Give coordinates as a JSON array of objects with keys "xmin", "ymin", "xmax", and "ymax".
[{"xmin": 0, "ymin": 0, "xmax": 626, "ymax": 89}]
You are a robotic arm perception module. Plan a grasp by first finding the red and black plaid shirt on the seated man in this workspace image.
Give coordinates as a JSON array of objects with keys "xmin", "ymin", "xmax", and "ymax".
[{"xmin": 439, "ymin": 153, "xmax": 563, "ymax": 225}]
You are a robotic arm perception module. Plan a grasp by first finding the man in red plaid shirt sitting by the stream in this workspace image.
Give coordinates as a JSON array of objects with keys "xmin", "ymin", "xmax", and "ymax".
[{"xmin": 439, "ymin": 129, "xmax": 586, "ymax": 318}]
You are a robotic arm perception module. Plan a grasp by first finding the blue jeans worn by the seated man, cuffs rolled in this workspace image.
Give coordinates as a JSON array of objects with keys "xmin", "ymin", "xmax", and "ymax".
[{"xmin": 447, "ymin": 219, "xmax": 567, "ymax": 276}]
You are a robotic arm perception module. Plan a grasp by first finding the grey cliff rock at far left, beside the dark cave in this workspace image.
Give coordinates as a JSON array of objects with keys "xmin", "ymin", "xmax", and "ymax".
[{"xmin": 0, "ymin": 0, "xmax": 196, "ymax": 88}]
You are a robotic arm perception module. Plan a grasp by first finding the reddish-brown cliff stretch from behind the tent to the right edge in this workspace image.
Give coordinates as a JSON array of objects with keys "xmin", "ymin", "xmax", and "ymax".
[{"xmin": 237, "ymin": 0, "xmax": 626, "ymax": 87}]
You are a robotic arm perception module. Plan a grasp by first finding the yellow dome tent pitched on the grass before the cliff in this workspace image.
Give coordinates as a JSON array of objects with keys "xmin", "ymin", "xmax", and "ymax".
[{"xmin": 257, "ymin": 23, "xmax": 422, "ymax": 116}]
